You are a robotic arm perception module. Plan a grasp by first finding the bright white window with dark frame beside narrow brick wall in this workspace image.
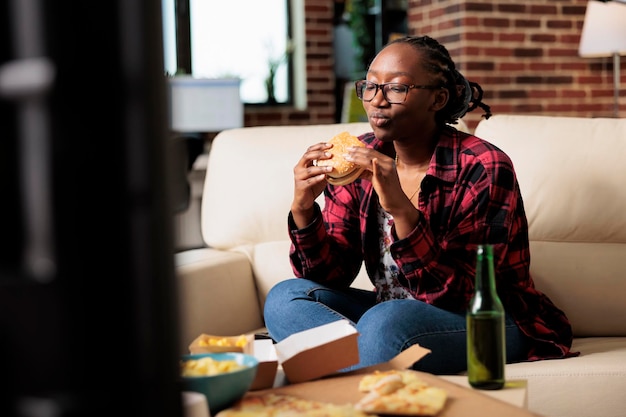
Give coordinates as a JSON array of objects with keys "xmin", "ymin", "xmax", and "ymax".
[{"xmin": 163, "ymin": 0, "xmax": 304, "ymax": 104}]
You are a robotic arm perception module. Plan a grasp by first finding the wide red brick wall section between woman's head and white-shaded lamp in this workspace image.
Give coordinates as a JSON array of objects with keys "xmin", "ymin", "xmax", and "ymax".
[{"xmin": 408, "ymin": 0, "xmax": 624, "ymax": 130}]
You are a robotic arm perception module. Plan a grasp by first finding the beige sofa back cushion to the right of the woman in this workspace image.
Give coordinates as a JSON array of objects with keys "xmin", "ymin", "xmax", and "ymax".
[{"xmin": 475, "ymin": 115, "xmax": 626, "ymax": 336}]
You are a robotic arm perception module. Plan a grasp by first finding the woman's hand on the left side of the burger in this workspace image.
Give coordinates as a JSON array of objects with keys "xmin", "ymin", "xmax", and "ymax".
[{"xmin": 291, "ymin": 142, "xmax": 332, "ymax": 229}]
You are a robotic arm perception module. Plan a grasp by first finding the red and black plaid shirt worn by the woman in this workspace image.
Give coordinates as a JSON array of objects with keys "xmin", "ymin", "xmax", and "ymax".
[{"xmin": 289, "ymin": 127, "xmax": 573, "ymax": 360}]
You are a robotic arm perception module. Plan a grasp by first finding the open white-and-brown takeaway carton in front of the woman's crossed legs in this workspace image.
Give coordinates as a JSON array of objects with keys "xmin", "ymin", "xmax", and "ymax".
[{"xmin": 274, "ymin": 320, "xmax": 359, "ymax": 384}]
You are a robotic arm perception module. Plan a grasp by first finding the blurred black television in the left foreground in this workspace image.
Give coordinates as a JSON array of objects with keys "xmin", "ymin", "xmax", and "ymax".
[{"xmin": 0, "ymin": 0, "xmax": 182, "ymax": 417}]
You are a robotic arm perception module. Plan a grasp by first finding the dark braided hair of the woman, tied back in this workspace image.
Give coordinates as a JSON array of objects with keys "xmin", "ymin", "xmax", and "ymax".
[{"xmin": 387, "ymin": 36, "xmax": 491, "ymax": 124}]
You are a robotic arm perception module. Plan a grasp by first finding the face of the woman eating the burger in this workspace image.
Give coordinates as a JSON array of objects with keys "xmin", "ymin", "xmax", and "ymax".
[{"xmin": 363, "ymin": 43, "xmax": 448, "ymax": 141}]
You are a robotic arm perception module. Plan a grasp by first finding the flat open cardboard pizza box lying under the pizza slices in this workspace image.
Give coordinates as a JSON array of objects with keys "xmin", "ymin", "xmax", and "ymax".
[{"xmin": 246, "ymin": 345, "xmax": 540, "ymax": 417}]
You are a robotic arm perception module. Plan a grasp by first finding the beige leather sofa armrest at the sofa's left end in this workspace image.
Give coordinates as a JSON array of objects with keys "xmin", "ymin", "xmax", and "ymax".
[{"xmin": 175, "ymin": 248, "xmax": 263, "ymax": 353}]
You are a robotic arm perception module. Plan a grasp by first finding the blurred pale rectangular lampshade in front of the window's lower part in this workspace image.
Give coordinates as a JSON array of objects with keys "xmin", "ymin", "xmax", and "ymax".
[{"xmin": 169, "ymin": 76, "xmax": 243, "ymax": 133}]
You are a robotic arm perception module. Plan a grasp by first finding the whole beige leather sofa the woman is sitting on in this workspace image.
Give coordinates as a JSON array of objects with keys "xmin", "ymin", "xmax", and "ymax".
[{"xmin": 176, "ymin": 115, "xmax": 626, "ymax": 417}]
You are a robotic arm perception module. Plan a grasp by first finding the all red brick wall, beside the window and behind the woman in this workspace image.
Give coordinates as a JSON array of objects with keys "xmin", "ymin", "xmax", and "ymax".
[{"xmin": 246, "ymin": 0, "xmax": 626, "ymax": 127}]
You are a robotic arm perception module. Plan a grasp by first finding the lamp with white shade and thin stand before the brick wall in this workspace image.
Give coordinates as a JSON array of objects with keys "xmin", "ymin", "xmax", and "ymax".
[{"xmin": 578, "ymin": 0, "xmax": 626, "ymax": 117}]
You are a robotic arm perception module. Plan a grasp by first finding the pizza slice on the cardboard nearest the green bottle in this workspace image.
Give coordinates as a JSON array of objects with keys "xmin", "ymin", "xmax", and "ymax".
[{"xmin": 355, "ymin": 370, "xmax": 447, "ymax": 416}]
